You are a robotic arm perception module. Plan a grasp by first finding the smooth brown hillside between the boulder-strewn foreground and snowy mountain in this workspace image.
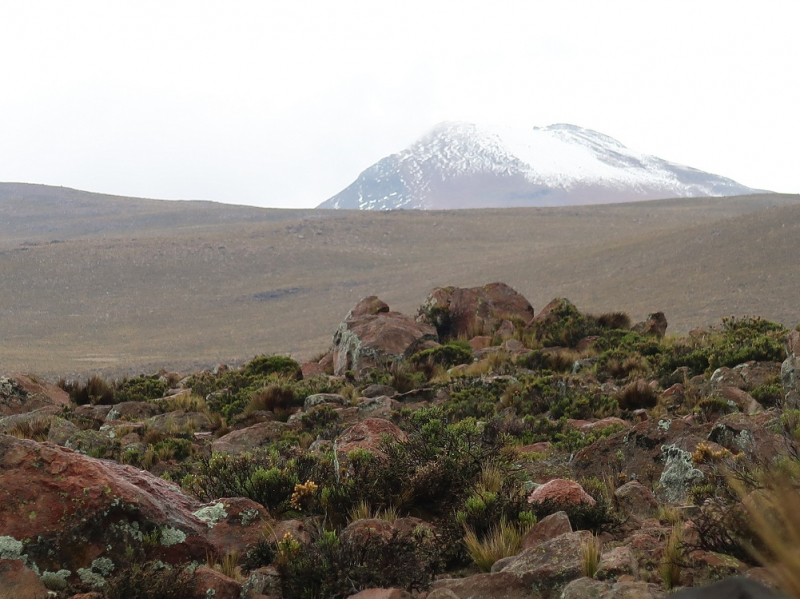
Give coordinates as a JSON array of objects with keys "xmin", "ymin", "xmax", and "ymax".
[{"xmin": 0, "ymin": 184, "xmax": 800, "ymax": 378}]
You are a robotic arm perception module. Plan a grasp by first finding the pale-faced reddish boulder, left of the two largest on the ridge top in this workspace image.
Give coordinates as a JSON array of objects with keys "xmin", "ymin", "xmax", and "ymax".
[{"xmin": 332, "ymin": 296, "xmax": 437, "ymax": 375}]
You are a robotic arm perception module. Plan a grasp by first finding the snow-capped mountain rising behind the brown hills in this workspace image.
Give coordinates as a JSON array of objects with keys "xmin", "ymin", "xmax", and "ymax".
[{"xmin": 318, "ymin": 122, "xmax": 759, "ymax": 210}]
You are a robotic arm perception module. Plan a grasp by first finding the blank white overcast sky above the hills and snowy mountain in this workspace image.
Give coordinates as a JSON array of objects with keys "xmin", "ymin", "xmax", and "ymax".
[{"xmin": 0, "ymin": 0, "xmax": 800, "ymax": 208}]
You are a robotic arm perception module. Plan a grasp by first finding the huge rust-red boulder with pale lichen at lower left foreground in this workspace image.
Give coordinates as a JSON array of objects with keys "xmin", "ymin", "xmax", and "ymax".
[{"xmin": 0, "ymin": 435, "xmax": 211, "ymax": 572}]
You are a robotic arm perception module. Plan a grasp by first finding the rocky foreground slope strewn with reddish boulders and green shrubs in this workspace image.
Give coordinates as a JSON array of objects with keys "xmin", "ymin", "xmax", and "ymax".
[{"xmin": 0, "ymin": 283, "xmax": 800, "ymax": 599}]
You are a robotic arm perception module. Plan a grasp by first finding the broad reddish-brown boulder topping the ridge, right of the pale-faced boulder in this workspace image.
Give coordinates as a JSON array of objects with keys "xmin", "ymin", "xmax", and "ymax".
[{"xmin": 417, "ymin": 283, "xmax": 533, "ymax": 337}]
